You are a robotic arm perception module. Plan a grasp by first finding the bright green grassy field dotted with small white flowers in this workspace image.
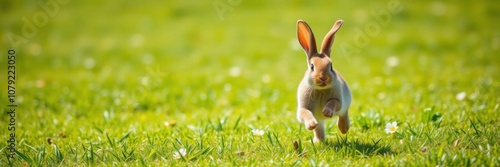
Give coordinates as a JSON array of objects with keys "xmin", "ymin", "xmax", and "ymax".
[{"xmin": 0, "ymin": 0, "xmax": 500, "ymax": 166}]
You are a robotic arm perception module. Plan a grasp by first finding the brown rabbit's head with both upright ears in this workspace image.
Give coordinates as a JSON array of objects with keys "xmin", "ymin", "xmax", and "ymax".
[{"xmin": 297, "ymin": 20, "xmax": 343, "ymax": 90}]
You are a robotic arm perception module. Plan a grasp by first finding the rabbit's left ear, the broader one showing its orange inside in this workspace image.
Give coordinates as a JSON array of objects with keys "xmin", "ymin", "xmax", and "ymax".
[{"xmin": 297, "ymin": 20, "xmax": 318, "ymax": 57}]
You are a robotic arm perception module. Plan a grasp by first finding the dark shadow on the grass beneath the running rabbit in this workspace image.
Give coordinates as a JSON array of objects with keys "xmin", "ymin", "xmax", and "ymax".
[{"xmin": 324, "ymin": 136, "xmax": 394, "ymax": 156}]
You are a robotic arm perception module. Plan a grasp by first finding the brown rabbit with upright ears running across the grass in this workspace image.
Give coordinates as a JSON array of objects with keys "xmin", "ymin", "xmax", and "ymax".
[{"xmin": 297, "ymin": 20, "xmax": 351, "ymax": 142}]
